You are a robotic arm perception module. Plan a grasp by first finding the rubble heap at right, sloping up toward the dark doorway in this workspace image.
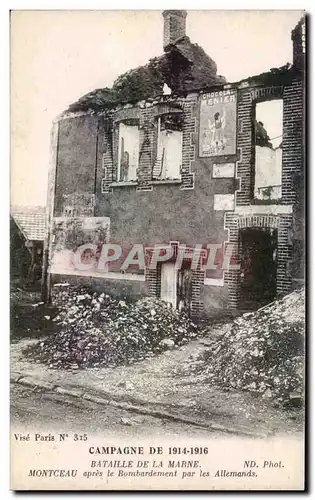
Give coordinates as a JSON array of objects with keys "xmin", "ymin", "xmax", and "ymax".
[{"xmin": 206, "ymin": 290, "xmax": 305, "ymax": 404}]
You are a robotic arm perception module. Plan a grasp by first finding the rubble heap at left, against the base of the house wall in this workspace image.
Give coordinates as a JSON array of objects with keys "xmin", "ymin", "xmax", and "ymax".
[{"xmin": 24, "ymin": 287, "xmax": 197, "ymax": 369}]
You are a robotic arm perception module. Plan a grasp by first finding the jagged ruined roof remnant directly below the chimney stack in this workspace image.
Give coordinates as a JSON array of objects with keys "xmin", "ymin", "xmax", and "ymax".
[{"xmin": 68, "ymin": 36, "xmax": 226, "ymax": 112}]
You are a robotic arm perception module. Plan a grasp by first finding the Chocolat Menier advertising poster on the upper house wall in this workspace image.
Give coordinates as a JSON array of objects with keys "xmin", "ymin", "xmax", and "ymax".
[{"xmin": 199, "ymin": 89, "xmax": 237, "ymax": 157}]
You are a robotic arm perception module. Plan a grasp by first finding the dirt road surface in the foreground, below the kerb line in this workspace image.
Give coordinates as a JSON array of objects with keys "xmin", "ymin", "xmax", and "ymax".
[{"xmin": 10, "ymin": 384, "xmax": 226, "ymax": 439}]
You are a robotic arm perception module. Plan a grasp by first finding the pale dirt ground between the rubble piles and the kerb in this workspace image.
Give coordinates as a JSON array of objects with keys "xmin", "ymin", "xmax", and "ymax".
[{"xmin": 11, "ymin": 325, "xmax": 303, "ymax": 435}]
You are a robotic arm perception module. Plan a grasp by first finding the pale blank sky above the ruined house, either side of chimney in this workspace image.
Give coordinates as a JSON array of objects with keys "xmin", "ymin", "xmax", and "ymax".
[{"xmin": 10, "ymin": 10, "xmax": 303, "ymax": 205}]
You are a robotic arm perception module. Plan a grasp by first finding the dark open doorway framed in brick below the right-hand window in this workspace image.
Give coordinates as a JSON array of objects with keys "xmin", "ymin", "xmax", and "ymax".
[{"xmin": 240, "ymin": 228, "xmax": 277, "ymax": 310}]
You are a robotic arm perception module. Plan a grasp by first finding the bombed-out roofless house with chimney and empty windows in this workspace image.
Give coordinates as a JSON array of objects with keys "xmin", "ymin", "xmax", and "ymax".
[{"xmin": 44, "ymin": 11, "xmax": 305, "ymax": 316}]
